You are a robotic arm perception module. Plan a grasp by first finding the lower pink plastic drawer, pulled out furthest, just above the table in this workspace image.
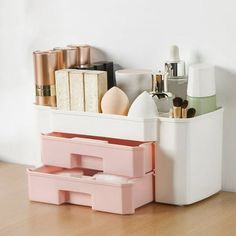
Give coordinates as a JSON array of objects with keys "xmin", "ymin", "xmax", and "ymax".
[{"xmin": 27, "ymin": 166, "xmax": 154, "ymax": 214}]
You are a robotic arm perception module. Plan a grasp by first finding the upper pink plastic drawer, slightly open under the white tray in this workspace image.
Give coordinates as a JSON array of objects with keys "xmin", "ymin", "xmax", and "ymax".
[{"xmin": 42, "ymin": 133, "xmax": 155, "ymax": 177}]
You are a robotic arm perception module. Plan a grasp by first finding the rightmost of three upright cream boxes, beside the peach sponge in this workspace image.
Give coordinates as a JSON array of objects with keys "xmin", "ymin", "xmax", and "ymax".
[{"xmin": 84, "ymin": 70, "xmax": 107, "ymax": 112}]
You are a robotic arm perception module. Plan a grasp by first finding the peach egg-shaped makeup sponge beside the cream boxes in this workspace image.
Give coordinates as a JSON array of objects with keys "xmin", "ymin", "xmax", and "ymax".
[{"xmin": 101, "ymin": 87, "xmax": 129, "ymax": 116}]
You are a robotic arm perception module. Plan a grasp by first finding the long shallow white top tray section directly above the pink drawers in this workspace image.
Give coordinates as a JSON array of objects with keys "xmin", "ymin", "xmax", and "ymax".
[{"xmin": 36, "ymin": 106, "xmax": 158, "ymax": 141}]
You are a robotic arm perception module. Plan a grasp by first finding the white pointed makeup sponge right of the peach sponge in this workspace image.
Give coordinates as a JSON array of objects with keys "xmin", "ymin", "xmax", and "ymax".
[{"xmin": 128, "ymin": 91, "xmax": 159, "ymax": 118}]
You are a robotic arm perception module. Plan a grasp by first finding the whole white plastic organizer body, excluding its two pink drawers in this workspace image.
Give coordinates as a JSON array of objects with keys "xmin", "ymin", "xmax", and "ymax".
[{"xmin": 36, "ymin": 106, "xmax": 223, "ymax": 205}]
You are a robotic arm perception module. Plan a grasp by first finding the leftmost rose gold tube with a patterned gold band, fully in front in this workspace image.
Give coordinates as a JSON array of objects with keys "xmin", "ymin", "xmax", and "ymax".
[{"xmin": 33, "ymin": 50, "xmax": 57, "ymax": 107}]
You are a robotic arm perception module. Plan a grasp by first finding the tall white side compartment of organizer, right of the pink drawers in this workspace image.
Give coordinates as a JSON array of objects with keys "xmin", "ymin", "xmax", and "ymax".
[{"xmin": 155, "ymin": 108, "xmax": 223, "ymax": 205}]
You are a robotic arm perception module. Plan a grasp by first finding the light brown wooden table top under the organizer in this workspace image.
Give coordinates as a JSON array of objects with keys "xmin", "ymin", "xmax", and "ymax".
[{"xmin": 0, "ymin": 162, "xmax": 236, "ymax": 236}]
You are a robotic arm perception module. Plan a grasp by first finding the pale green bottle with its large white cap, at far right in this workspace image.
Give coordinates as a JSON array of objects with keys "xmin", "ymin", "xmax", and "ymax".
[{"xmin": 187, "ymin": 64, "xmax": 216, "ymax": 115}]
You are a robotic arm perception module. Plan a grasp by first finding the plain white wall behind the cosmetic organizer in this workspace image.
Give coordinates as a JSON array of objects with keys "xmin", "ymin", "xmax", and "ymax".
[{"xmin": 0, "ymin": 0, "xmax": 236, "ymax": 191}]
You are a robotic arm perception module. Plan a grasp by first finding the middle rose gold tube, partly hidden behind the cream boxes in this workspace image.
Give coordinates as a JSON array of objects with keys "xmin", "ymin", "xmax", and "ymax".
[{"xmin": 53, "ymin": 47, "xmax": 79, "ymax": 69}]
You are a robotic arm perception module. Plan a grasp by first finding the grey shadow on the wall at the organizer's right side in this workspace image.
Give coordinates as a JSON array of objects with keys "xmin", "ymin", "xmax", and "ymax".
[{"xmin": 215, "ymin": 67, "xmax": 236, "ymax": 191}]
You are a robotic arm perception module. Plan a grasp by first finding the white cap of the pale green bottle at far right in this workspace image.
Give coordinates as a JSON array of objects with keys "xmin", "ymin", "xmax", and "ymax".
[{"xmin": 187, "ymin": 64, "xmax": 216, "ymax": 97}]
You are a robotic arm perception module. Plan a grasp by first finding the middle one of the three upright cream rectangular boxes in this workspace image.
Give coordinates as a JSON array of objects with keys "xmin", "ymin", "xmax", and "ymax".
[{"xmin": 69, "ymin": 70, "xmax": 85, "ymax": 111}]
